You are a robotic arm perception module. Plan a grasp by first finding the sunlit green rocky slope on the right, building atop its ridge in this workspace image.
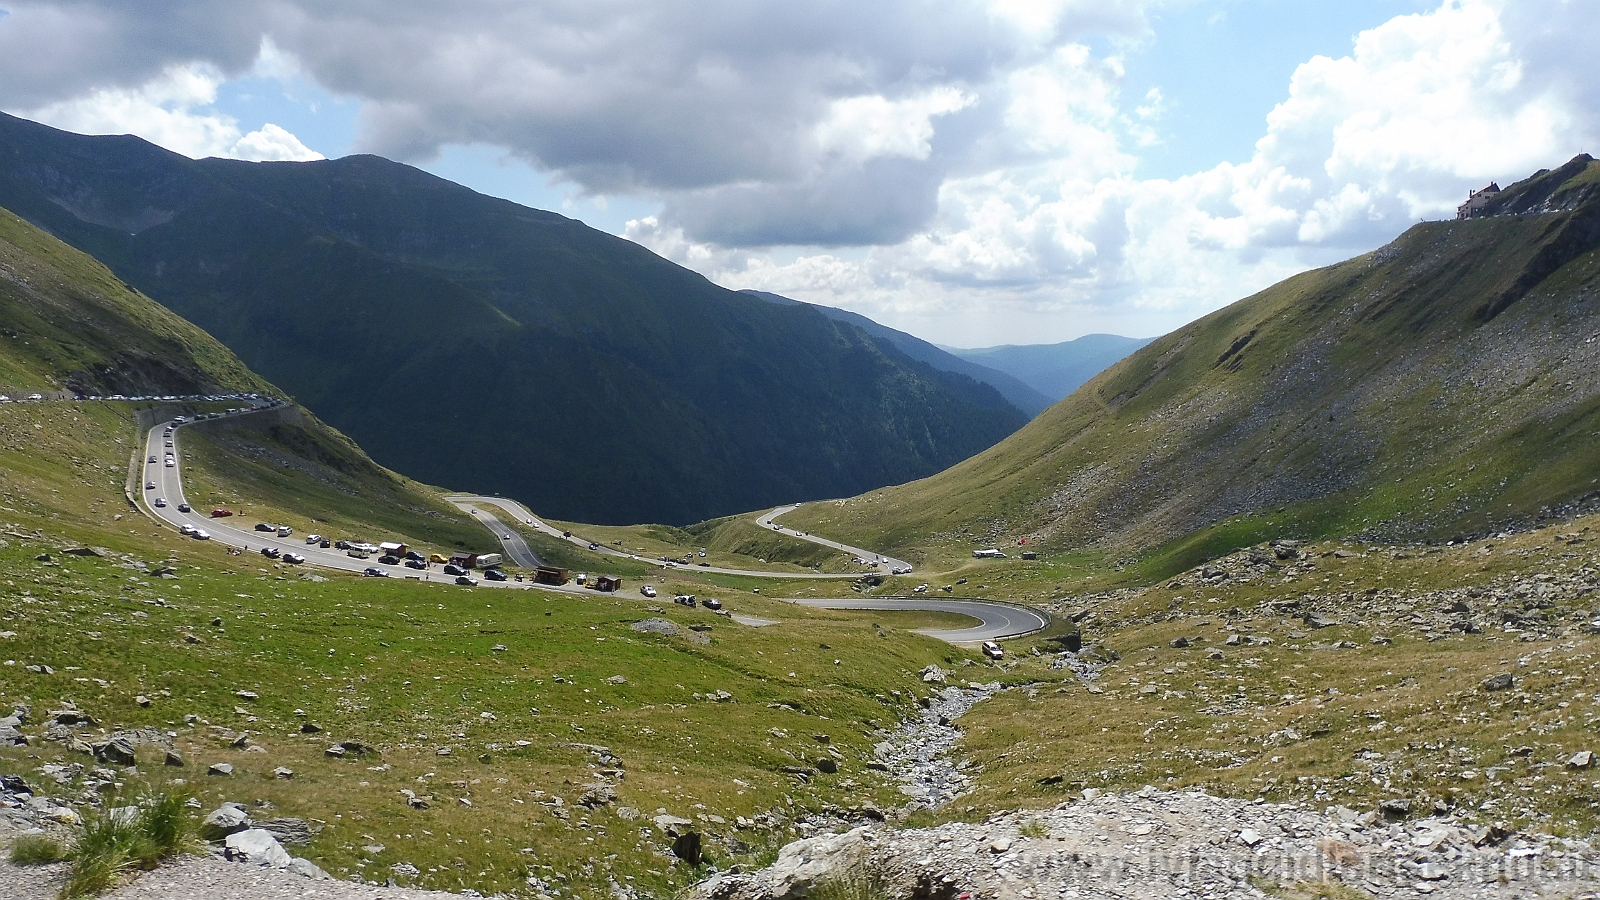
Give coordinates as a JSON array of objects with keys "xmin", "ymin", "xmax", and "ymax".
[{"xmin": 790, "ymin": 157, "xmax": 1600, "ymax": 565}]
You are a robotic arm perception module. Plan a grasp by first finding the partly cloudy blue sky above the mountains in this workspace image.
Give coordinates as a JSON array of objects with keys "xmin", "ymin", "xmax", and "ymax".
[{"xmin": 0, "ymin": 0, "xmax": 1600, "ymax": 348}]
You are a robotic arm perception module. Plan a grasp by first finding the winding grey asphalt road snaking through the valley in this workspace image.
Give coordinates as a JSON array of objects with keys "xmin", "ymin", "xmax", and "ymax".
[{"xmin": 134, "ymin": 405, "xmax": 1050, "ymax": 644}]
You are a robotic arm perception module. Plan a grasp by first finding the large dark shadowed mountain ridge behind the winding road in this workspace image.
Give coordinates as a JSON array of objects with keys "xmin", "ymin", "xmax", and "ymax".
[{"xmin": 0, "ymin": 117, "xmax": 1026, "ymax": 522}]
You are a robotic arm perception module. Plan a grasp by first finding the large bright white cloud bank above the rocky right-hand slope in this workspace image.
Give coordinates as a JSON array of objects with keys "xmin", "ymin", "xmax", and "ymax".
[{"xmin": 638, "ymin": 0, "xmax": 1600, "ymax": 346}]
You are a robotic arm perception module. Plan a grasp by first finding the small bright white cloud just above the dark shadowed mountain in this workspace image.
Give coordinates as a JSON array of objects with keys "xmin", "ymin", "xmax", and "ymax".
[{"xmin": 22, "ymin": 64, "xmax": 323, "ymax": 160}]
